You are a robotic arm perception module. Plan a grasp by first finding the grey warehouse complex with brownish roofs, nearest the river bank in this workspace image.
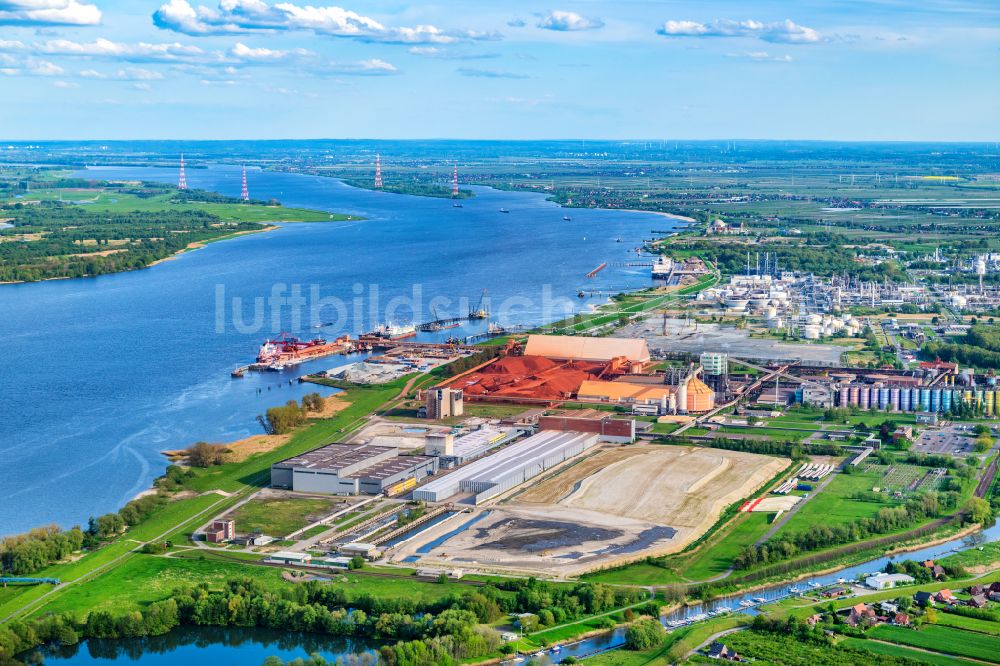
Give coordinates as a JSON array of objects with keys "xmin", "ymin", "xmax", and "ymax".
[{"xmin": 271, "ymin": 444, "xmax": 437, "ymax": 495}]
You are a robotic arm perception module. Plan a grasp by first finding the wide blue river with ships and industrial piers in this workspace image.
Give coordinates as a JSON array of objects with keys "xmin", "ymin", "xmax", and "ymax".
[{"xmin": 0, "ymin": 166, "xmax": 675, "ymax": 535}]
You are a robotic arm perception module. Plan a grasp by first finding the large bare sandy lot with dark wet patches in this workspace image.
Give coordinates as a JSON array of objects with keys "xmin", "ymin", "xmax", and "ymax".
[{"xmin": 392, "ymin": 446, "xmax": 789, "ymax": 577}]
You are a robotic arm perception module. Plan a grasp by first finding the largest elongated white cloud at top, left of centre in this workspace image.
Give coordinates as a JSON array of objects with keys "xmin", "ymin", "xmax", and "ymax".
[{"xmin": 152, "ymin": 0, "xmax": 496, "ymax": 44}]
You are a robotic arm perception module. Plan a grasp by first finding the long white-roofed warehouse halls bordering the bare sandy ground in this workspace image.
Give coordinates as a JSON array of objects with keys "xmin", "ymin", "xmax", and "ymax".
[{"xmin": 413, "ymin": 430, "xmax": 598, "ymax": 504}]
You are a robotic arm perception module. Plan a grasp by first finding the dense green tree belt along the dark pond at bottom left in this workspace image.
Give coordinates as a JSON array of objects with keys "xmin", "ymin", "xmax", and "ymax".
[{"xmin": 0, "ymin": 578, "xmax": 646, "ymax": 666}]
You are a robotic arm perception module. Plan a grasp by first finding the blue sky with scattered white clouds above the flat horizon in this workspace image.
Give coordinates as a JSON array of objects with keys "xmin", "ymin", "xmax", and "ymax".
[{"xmin": 0, "ymin": 0, "xmax": 1000, "ymax": 141}]
